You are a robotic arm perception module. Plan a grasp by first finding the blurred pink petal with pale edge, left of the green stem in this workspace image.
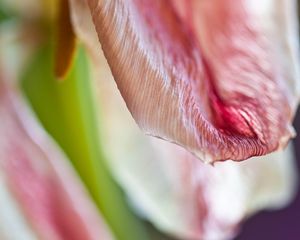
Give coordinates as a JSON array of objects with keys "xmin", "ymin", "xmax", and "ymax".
[{"xmin": 0, "ymin": 82, "xmax": 111, "ymax": 240}]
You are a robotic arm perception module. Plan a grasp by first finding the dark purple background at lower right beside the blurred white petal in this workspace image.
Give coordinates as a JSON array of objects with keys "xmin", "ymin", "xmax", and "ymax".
[{"xmin": 236, "ymin": 111, "xmax": 300, "ymax": 240}]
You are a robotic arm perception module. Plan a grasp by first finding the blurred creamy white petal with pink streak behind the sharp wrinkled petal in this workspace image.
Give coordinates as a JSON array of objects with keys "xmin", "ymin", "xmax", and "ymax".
[{"xmin": 97, "ymin": 54, "xmax": 296, "ymax": 240}]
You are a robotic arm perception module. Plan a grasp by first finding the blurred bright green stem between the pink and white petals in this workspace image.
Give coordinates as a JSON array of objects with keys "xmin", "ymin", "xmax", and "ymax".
[{"xmin": 22, "ymin": 41, "xmax": 148, "ymax": 240}]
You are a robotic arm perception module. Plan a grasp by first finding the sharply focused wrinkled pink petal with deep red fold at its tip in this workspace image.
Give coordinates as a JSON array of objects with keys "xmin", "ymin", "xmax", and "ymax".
[{"xmin": 88, "ymin": 0, "xmax": 299, "ymax": 162}]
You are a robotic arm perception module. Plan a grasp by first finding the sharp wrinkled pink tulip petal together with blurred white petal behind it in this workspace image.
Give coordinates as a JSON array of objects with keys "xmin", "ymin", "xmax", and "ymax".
[{"xmin": 71, "ymin": 0, "xmax": 299, "ymax": 239}]
